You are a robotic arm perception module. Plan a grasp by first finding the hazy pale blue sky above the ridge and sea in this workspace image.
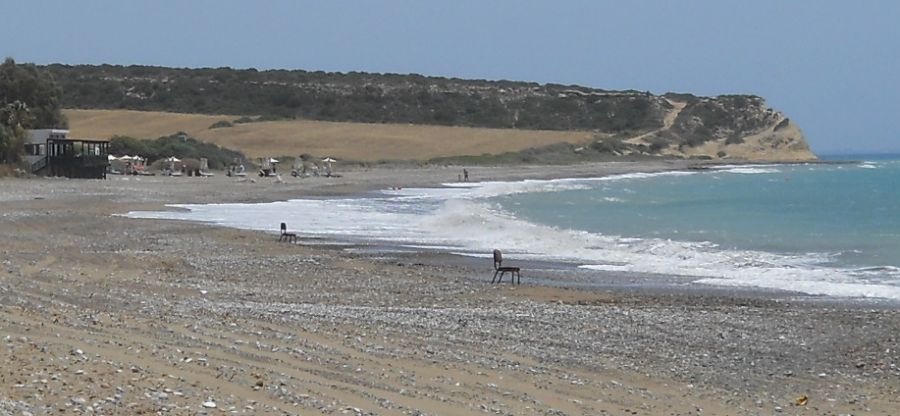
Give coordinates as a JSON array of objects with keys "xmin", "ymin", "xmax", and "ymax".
[{"xmin": 0, "ymin": 0, "xmax": 900, "ymax": 153}]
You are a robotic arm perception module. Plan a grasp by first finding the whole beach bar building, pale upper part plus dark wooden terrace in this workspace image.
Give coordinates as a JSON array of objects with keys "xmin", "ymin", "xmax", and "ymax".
[{"xmin": 25, "ymin": 129, "xmax": 109, "ymax": 179}]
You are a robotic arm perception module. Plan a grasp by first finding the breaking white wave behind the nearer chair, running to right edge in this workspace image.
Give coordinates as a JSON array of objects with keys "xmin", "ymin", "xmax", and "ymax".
[{"xmin": 420, "ymin": 201, "xmax": 900, "ymax": 299}]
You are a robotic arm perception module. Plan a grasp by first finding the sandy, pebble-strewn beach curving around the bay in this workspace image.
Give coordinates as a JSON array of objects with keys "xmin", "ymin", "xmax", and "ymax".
[{"xmin": 0, "ymin": 161, "xmax": 900, "ymax": 415}]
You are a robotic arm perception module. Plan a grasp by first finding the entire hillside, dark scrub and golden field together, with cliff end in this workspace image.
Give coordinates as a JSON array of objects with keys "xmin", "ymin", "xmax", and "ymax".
[{"xmin": 46, "ymin": 65, "xmax": 815, "ymax": 160}]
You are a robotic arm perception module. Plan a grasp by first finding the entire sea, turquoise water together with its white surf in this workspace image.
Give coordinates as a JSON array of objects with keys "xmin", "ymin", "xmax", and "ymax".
[{"xmin": 128, "ymin": 156, "xmax": 900, "ymax": 301}]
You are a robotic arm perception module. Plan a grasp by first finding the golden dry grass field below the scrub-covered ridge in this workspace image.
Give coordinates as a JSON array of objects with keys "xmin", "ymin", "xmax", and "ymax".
[{"xmin": 64, "ymin": 110, "xmax": 592, "ymax": 161}]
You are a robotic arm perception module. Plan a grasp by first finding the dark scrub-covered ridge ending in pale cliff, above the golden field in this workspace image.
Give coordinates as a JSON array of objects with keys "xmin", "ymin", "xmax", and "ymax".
[{"xmin": 46, "ymin": 64, "xmax": 815, "ymax": 160}]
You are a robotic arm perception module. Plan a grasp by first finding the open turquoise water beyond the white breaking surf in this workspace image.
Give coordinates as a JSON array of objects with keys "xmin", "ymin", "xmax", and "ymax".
[{"xmin": 497, "ymin": 158, "xmax": 900, "ymax": 268}]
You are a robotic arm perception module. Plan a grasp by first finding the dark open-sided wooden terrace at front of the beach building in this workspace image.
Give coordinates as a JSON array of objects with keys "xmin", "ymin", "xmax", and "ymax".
[{"xmin": 44, "ymin": 139, "xmax": 109, "ymax": 179}]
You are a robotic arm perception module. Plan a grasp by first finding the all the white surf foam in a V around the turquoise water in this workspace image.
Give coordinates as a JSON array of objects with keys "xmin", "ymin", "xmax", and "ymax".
[{"xmin": 127, "ymin": 168, "xmax": 900, "ymax": 300}]
